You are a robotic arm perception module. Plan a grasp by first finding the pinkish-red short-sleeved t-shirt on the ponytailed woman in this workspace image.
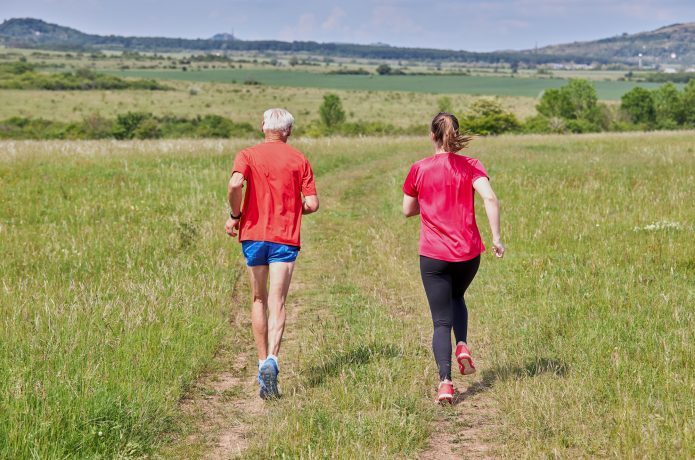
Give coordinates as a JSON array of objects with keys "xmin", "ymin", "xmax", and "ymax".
[{"xmin": 403, "ymin": 153, "xmax": 487, "ymax": 262}]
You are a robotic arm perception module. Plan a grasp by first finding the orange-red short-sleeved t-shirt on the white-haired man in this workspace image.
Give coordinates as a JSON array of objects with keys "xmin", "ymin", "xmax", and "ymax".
[{"xmin": 232, "ymin": 141, "xmax": 316, "ymax": 246}]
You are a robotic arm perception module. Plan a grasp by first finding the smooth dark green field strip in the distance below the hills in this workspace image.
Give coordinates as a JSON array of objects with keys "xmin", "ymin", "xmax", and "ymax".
[{"xmin": 109, "ymin": 69, "xmax": 680, "ymax": 100}]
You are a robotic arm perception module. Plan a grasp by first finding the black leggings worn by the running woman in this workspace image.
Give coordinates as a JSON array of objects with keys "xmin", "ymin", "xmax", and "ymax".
[{"xmin": 420, "ymin": 256, "xmax": 480, "ymax": 380}]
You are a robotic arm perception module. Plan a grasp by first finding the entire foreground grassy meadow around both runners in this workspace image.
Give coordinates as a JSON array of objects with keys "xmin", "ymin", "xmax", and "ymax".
[{"xmin": 0, "ymin": 131, "xmax": 695, "ymax": 458}]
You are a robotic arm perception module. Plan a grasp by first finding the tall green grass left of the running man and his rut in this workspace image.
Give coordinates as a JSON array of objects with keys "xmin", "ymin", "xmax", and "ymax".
[{"xmin": 0, "ymin": 139, "xmax": 250, "ymax": 458}]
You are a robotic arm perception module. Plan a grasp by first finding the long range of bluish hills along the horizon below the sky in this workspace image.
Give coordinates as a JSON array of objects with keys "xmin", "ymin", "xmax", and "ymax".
[{"xmin": 0, "ymin": 18, "xmax": 695, "ymax": 65}]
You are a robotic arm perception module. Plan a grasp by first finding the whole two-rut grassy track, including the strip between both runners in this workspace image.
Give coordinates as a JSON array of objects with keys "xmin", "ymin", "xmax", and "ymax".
[{"xmin": 162, "ymin": 141, "xmax": 498, "ymax": 460}]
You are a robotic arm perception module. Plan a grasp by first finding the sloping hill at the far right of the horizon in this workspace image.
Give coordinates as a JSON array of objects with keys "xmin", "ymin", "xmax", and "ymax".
[{"xmin": 525, "ymin": 22, "xmax": 695, "ymax": 65}]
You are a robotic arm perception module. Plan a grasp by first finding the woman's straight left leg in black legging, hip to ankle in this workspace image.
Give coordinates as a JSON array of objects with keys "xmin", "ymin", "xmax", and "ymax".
[{"xmin": 420, "ymin": 256, "xmax": 454, "ymax": 380}]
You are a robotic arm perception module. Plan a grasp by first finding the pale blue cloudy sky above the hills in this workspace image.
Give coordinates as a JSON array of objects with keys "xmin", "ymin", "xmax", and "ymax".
[{"xmin": 0, "ymin": 0, "xmax": 695, "ymax": 51}]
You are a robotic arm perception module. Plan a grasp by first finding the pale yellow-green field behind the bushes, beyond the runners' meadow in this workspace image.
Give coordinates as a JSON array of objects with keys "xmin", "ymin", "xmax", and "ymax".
[{"xmin": 0, "ymin": 82, "xmax": 537, "ymax": 128}]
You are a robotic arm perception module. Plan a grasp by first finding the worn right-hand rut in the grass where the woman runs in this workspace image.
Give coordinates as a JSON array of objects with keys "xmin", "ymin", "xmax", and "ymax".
[{"xmin": 348, "ymin": 161, "xmax": 502, "ymax": 459}]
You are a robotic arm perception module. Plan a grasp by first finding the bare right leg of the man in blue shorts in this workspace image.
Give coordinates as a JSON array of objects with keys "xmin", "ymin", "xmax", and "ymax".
[{"xmin": 264, "ymin": 262, "xmax": 294, "ymax": 358}]
